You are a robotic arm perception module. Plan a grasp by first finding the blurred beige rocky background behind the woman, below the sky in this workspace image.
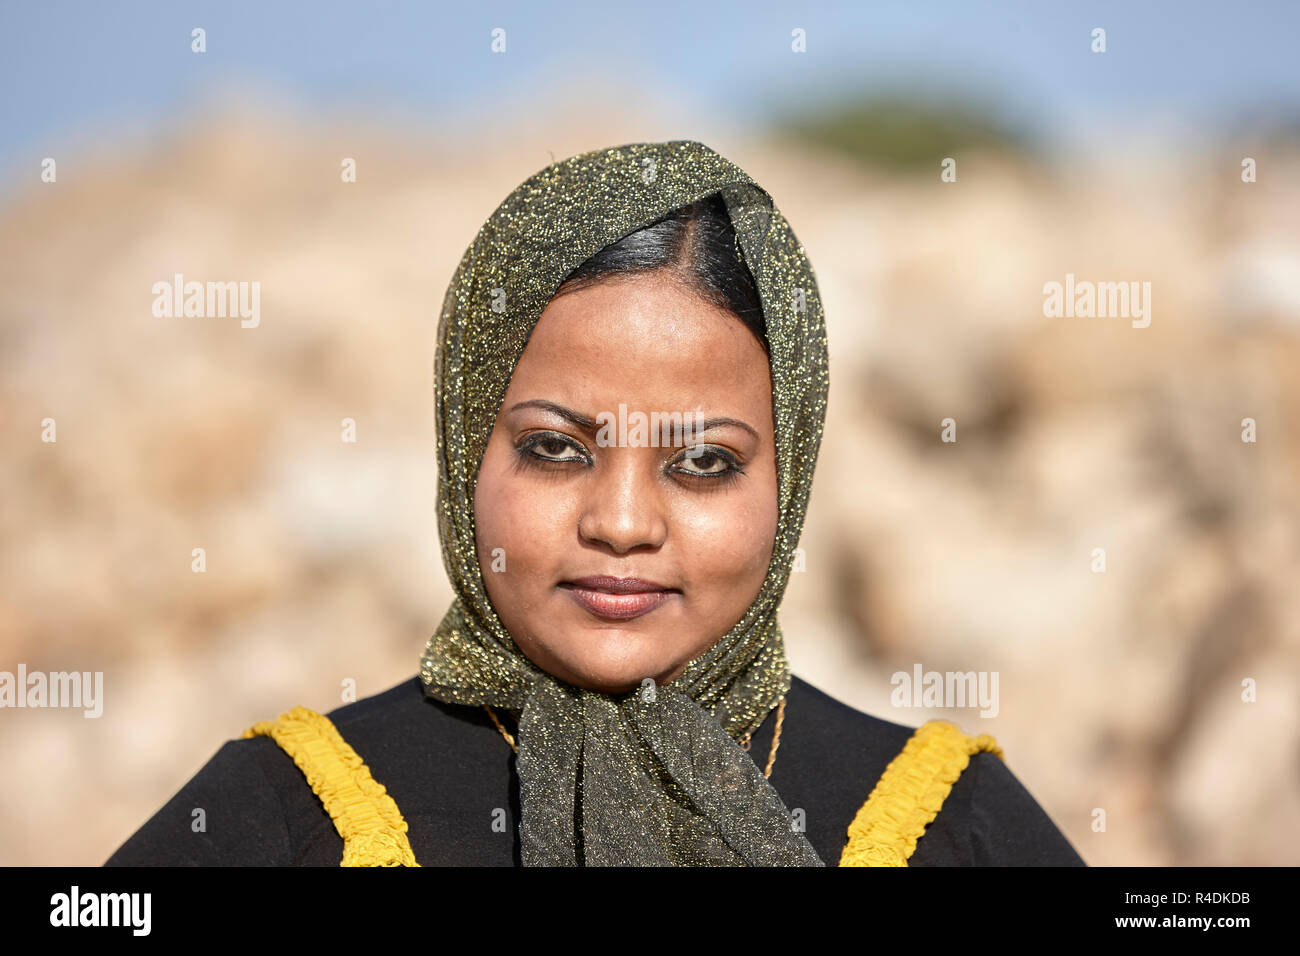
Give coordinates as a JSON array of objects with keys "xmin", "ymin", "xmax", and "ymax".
[{"xmin": 0, "ymin": 1, "xmax": 1300, "ymax": 865}]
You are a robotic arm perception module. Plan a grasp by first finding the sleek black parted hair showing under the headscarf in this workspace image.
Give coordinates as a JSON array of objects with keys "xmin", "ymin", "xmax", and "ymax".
[{"xmin": 553, "ymin": 193, "xmax": 768, "ymax": 351}]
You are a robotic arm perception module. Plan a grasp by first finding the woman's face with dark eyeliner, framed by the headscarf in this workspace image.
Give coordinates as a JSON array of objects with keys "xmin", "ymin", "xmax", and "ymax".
[{"xmin": 475, "ymin": 273, "xmax": 777, "ymax": 693}]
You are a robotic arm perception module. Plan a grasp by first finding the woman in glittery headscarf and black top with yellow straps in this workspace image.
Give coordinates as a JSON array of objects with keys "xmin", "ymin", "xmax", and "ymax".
[{"xmin": 101, "ymin": 142, "xmax": 1083, "ymax": 866}]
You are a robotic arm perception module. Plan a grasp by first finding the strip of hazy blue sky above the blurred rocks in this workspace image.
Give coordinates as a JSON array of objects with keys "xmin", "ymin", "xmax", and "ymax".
[{"xmin": 0, "ymin": 0, "xmax": 1300, "ymax": 160}]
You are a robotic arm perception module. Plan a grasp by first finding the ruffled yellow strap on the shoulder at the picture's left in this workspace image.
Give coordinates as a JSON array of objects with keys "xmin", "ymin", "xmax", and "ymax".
[{"xmin": 243, "ymin": 708, "xmax": 420, "ymax": 866}]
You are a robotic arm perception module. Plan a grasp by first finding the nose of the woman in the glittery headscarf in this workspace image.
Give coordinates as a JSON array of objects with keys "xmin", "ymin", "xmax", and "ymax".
[{"xmin": 577, "ymin": 449, "xmax": 668, "ymax": 554}]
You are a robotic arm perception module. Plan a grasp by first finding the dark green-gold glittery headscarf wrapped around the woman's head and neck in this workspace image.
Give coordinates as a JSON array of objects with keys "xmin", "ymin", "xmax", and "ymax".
[{"xmin": 420, "ymin": 140, "xmax": 828, "ymax": 866}]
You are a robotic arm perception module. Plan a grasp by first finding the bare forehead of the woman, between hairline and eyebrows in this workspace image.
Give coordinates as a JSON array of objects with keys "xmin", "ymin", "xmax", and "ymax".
[{"xmin": 510, "ymin": 276, "xmax": 771, "ymax": 415}]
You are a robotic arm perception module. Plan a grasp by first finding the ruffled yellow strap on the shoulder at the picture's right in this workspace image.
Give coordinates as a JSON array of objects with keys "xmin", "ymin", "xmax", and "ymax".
[{"xmin": 840, "ymin": 721, "xmax": 1006, "ymax": 866}]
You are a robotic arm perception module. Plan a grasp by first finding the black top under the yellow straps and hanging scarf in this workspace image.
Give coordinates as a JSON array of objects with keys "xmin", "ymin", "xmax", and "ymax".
[{"xmin": 105, "ymin": 678, "xmax": 1084, "ymax": 866}]
